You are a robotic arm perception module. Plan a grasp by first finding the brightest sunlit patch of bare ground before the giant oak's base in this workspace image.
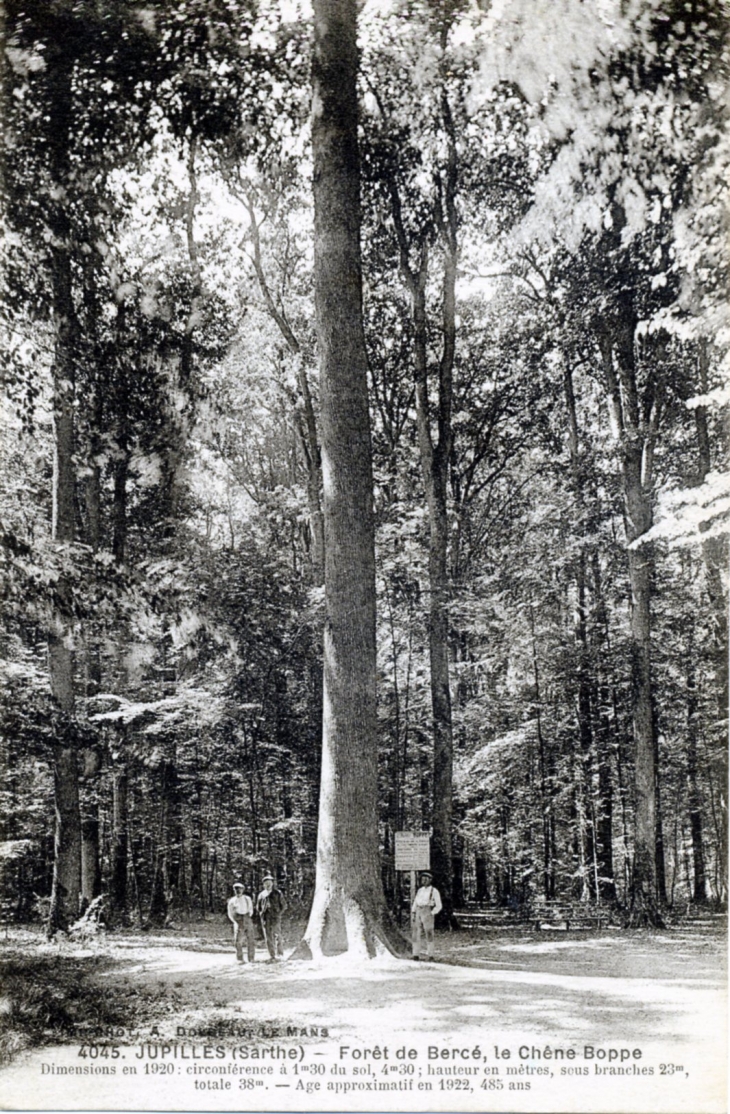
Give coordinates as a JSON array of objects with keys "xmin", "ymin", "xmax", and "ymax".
[{"xmin": 99, "ymin": 937, "xmax": 724, "ymax": 1040}]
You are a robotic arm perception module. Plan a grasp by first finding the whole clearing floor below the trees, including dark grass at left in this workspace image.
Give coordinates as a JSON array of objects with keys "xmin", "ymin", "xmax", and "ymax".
[{"xmin": 0, "ymin": 921, "xmax": 727, "ymax": 1111}]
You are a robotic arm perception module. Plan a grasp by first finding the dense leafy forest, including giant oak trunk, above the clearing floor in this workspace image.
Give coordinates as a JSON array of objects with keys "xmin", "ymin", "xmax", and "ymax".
[{"xmin": 0, "ymin": 0, "xmax": 730, "ymax": 951}]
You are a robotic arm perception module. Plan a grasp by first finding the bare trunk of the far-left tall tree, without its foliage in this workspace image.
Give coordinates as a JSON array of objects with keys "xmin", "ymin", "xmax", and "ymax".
[{"xmin": 48, "ymin": 46, "xmax": 81, "ymax": 936}]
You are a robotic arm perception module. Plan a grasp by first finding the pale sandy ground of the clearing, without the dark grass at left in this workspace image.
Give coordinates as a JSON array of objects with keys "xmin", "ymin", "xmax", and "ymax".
[{"xmin": 0, "ymin": 927, "xmax": 727, "ymax": 1114}]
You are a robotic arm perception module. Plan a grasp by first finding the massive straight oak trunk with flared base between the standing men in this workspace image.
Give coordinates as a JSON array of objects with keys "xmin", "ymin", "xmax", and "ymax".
[{"xmin": 304, "ymin": 0, "xmax": 403, "ymax": 958}]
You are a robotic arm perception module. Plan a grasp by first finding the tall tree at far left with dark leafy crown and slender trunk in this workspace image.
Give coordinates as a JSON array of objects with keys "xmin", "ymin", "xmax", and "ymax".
[{"xmin": 3, "ymin": 0, "xmax": 158, "ymax": 934}]
